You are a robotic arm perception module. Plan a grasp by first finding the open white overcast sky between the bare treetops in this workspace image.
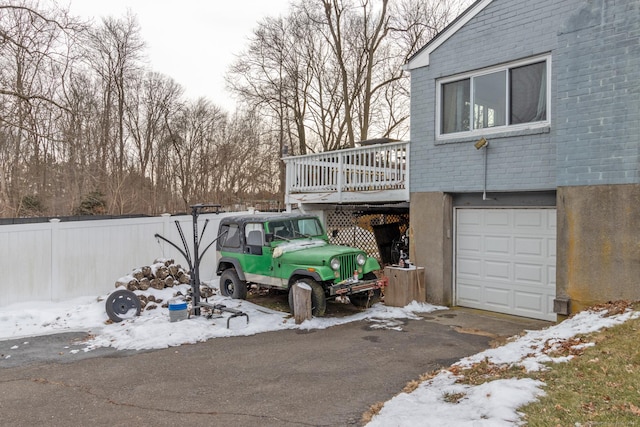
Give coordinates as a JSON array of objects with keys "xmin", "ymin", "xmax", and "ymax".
[{"xmin": 68, "ymin": 0, "xmax": 290, "ymax": 110}]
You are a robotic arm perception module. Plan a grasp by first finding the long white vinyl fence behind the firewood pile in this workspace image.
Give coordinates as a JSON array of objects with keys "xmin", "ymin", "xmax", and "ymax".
[{"xmin": 0, "ymin": 212, "xmax": 250, "ymax": 307}]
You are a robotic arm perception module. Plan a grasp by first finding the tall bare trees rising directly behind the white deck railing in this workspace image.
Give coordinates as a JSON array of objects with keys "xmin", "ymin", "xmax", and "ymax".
[{"xmin": 227, "ymin": 0, "xmax": 454, "ymax": 159}]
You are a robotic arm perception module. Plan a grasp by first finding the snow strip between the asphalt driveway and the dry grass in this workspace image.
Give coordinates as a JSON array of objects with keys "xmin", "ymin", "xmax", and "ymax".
[{"xmin": 367, "ymin": 310, "xmax": 640, "ymax": 427}]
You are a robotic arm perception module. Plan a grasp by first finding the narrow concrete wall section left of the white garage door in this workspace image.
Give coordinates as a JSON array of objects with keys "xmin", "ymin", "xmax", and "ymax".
[{"xmin": 409, "ymin": 192, "xmax": 453, "ymax": 305}]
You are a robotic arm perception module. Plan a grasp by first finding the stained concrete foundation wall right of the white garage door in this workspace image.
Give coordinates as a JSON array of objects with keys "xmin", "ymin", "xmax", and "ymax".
[{"xmin": 557, "ymin": 184, "xmax": 640, "ymax": 312}]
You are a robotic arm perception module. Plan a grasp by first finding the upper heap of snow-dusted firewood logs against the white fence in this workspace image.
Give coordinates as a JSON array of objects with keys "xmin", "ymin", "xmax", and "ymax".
[{"xmin": 116, "ymin": 259, "xmax": 191, "ymax": 291}]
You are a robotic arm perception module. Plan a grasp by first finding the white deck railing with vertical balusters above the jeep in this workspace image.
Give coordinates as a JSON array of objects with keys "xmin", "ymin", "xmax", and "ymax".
[{"xmin": 283, "ymin": 142, "xmax": 409, "ymax": 203}]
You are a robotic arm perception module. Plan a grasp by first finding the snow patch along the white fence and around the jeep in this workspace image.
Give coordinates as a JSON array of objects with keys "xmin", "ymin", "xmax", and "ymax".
[{"xmin": 0, "ymin": 281, "xmax": 444, "ymax": 350}]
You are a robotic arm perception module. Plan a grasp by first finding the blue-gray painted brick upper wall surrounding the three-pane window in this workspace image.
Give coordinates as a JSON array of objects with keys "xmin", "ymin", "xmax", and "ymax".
[{"xmin": 411, "ymin": 0, "xmax": 640, "ymax": 192}]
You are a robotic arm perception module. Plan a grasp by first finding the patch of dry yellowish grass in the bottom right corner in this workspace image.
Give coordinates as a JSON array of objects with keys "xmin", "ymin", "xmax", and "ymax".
[{"xmin": 520, "ymin": 306, "xmax": 640, "ymax": 426}]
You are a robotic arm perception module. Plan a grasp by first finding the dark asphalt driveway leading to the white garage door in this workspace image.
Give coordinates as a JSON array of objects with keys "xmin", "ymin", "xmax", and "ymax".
[{"xmin": 0, "ymin": 309, "xmax": 549, "ymax": 426}]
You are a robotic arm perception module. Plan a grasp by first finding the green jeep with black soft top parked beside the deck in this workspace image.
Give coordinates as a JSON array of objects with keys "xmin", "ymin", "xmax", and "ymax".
[{"xmin": 216, "ymin": 214, "xmax": 386, "ymax": 316}]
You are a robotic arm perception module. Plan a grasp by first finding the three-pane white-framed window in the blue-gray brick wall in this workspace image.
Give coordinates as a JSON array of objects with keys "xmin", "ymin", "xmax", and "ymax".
[{"xmin": 439, "ymin": 60, "xmax": 548, "ymax": 135}]
